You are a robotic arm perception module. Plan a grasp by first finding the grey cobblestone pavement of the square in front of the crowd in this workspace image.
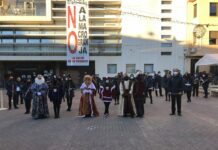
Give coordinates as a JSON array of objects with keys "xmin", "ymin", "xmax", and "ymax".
[{"xmin": 0, "ymin": 92, "xmax": 218, "ymax": 150}]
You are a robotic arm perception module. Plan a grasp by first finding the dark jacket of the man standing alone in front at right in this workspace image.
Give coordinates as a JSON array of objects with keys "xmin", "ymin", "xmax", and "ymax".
[{"xmin": 169, "ymin": 75, "xmax": 184, "ymax": 94}]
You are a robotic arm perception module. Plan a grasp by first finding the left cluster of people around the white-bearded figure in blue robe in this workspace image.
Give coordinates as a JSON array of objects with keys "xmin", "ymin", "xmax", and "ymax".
[{"xmin": 6, "ymin": 75, "xmax": 76, "ymax": 119}]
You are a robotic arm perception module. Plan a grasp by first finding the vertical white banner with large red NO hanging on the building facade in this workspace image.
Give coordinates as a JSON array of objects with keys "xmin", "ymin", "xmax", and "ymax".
[{"xmin": 66, "ymin": 0, "xmax": 89, "ymax": 66}]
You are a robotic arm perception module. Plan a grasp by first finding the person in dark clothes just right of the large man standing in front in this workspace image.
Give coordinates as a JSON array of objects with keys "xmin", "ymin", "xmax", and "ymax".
[{"xmin": 183, "ymin": 73, "xmax": 193, "ymax": 103}]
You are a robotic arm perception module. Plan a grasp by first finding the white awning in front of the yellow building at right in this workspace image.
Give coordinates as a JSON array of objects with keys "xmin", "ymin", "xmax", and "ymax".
[{"xmin": 195, "ymin": 54, "xmax": 218, "ymax": 68}]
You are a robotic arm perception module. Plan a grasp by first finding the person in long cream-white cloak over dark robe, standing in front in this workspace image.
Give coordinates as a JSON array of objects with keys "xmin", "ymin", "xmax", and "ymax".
[{"xmin": 119, "ymin": 74, "xmax": 135, "ymax": 118}]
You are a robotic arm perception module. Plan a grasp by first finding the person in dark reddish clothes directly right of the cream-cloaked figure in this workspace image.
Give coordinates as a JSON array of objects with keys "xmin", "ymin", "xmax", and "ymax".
[{"xmin": 133, "ymin": 74, "xmax": 145, "ymax": 117}]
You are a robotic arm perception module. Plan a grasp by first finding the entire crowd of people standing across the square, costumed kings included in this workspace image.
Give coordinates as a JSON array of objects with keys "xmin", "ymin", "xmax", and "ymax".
[{"xmin": 6, "ymin": 69, "xmax": 210, "ymax": 119}]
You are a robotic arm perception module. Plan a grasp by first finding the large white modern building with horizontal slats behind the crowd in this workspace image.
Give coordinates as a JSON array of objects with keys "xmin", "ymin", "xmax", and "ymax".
[{"xmin": 0, "ymin": 0, "xmax": 186, "ymax": 86}]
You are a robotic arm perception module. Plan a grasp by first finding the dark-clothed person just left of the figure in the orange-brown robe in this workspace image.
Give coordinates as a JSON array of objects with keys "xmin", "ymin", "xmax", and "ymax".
[{"xmin": 64, "ymin": 76, "xmax": 76, "ymax": 111}]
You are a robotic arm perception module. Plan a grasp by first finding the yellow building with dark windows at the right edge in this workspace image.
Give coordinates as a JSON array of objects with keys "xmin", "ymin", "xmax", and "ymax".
[{"xmin": 186, "ymin": 0, "xmax": 218, "ymax": 73}]
